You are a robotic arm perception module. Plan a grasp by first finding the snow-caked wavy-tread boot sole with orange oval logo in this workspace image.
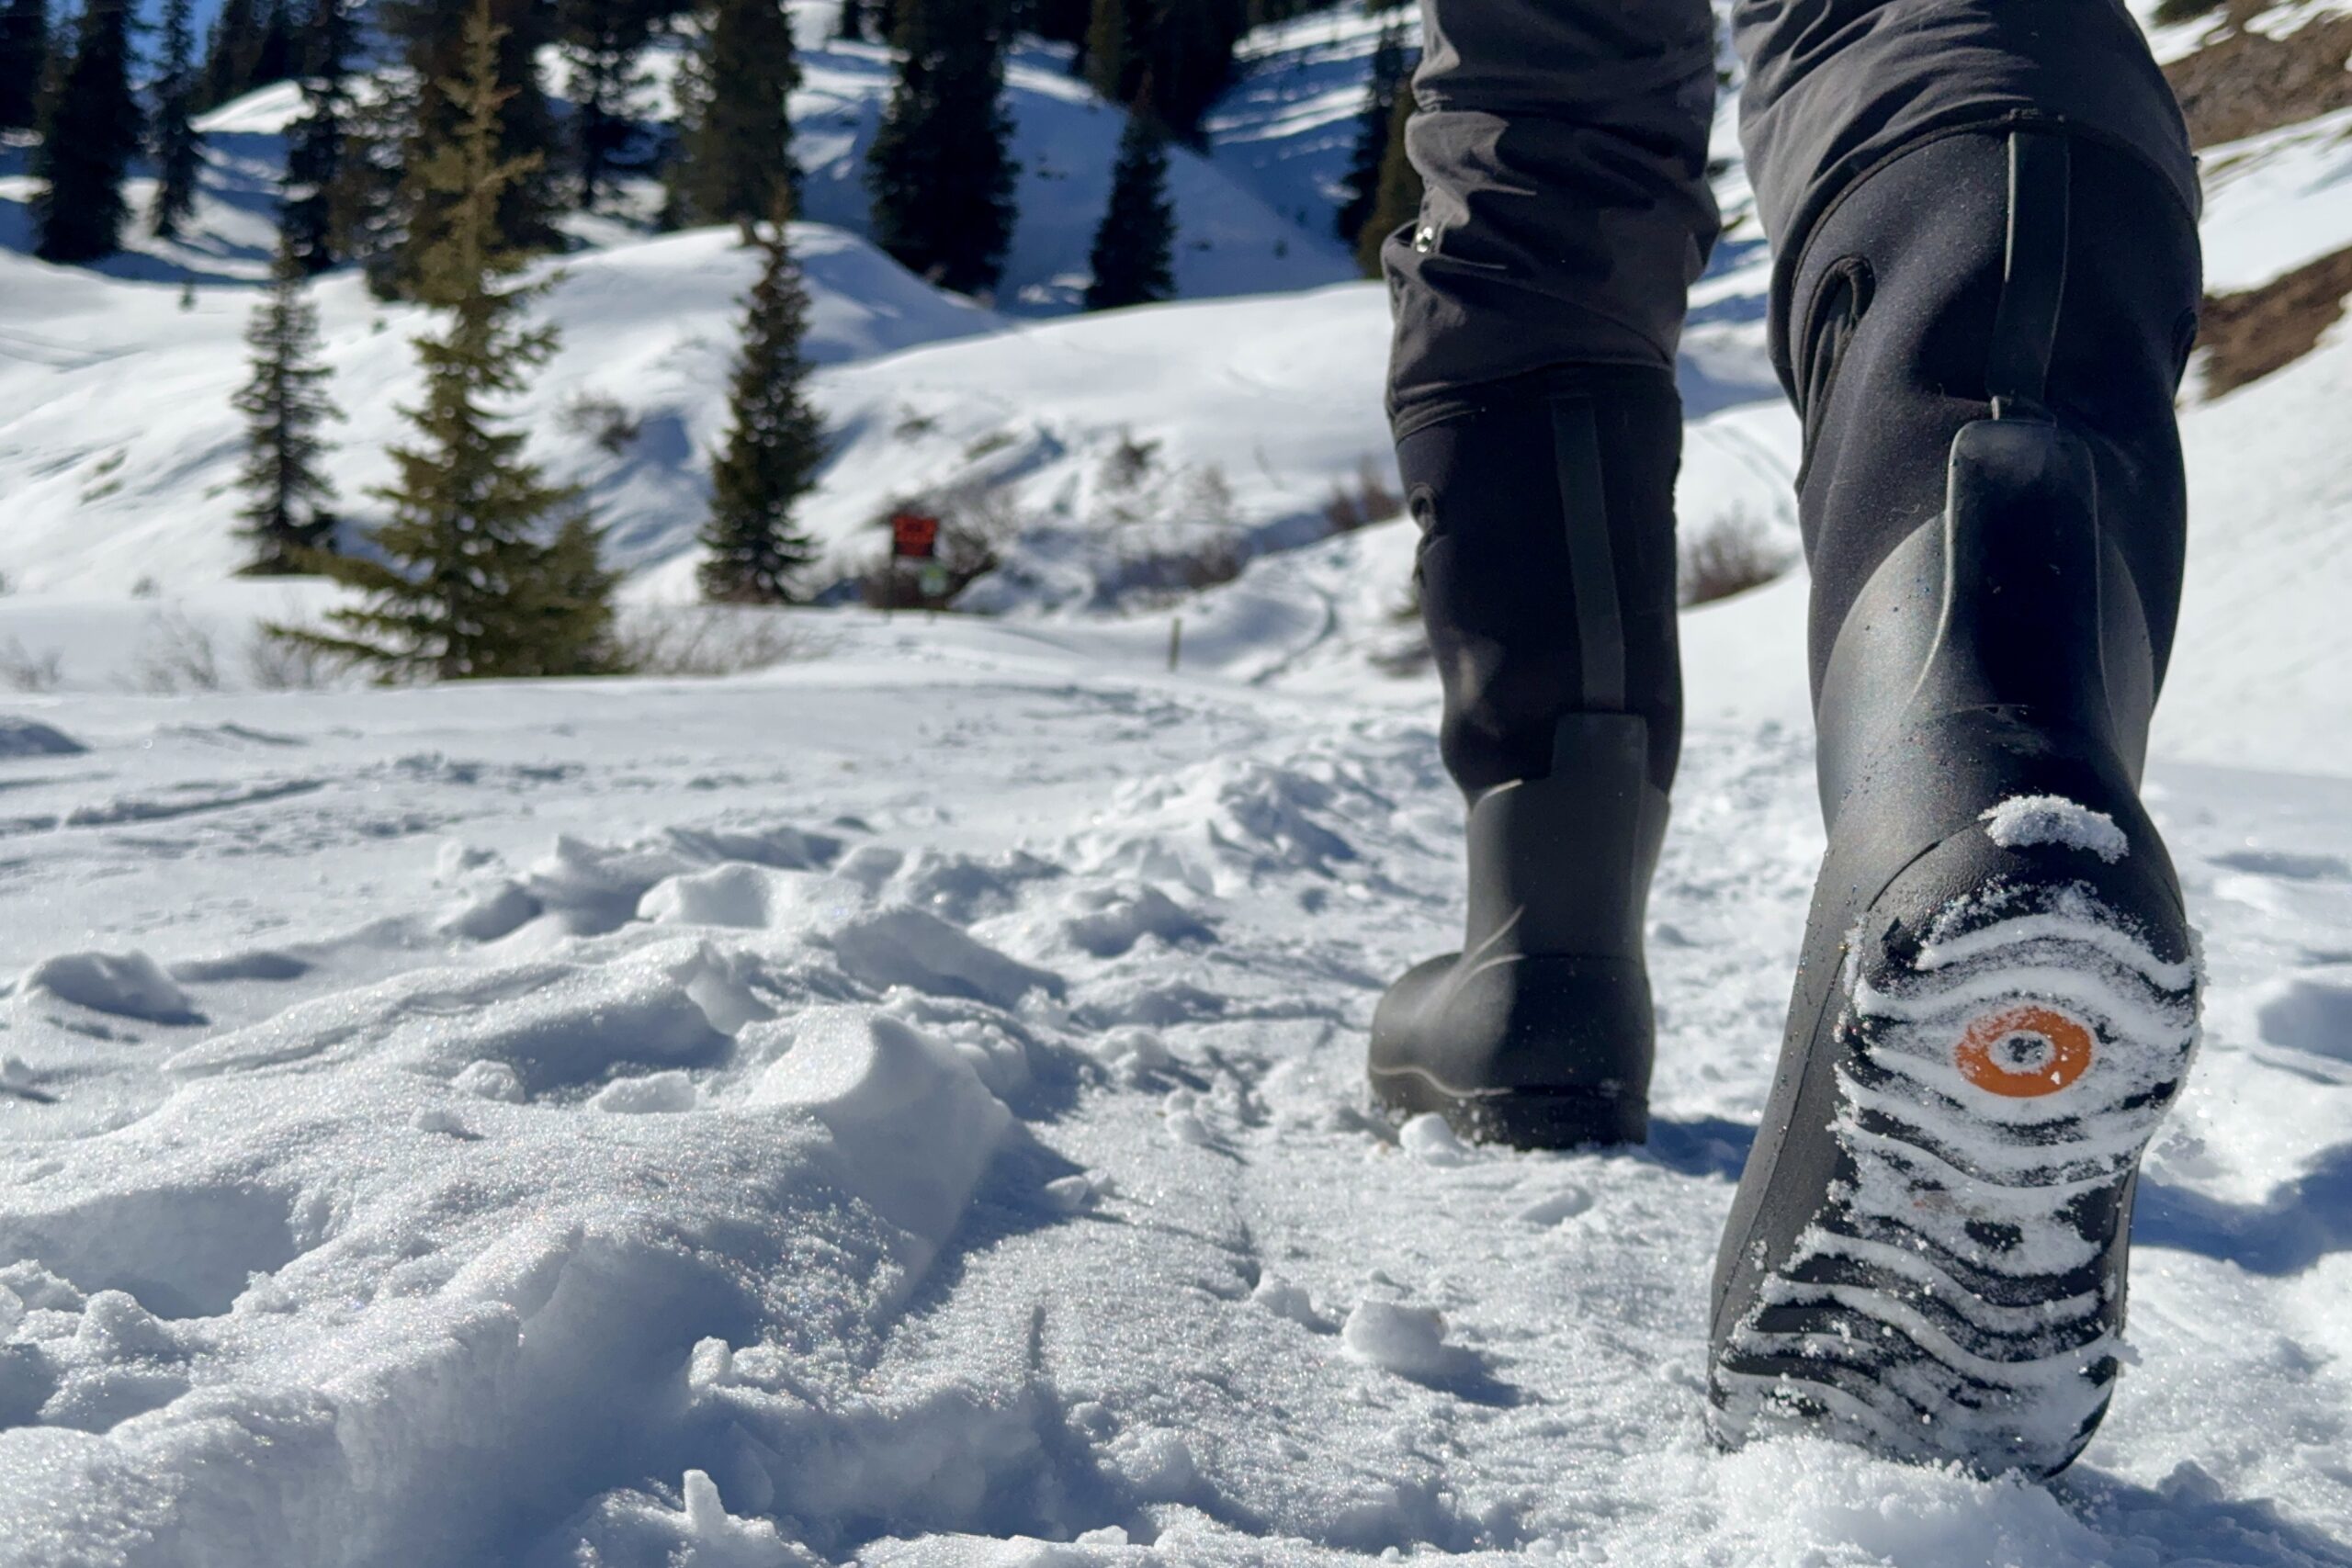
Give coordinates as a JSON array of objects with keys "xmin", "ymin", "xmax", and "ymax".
[{"xmin": 1713, "ymin": 864, "xmax": 2199, "ymax": 1476}]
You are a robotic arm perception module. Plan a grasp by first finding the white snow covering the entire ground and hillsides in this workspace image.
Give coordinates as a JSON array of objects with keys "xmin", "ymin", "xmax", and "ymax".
[{"xmin": 0, "ymin": 5, "xmax": 2352, "ymax": 1568}]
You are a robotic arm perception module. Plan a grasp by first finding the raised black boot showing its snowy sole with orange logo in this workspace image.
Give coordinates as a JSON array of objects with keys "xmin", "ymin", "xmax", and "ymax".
[{"xmin": 1713, "ymin": 130, "xmax": 2199, "ymax": 1474}]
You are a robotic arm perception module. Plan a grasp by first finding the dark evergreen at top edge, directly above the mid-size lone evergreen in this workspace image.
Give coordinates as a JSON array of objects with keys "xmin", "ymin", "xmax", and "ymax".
[{"xmin": 671, "ymin": 0, "xmax": 804, "ymax": 231}]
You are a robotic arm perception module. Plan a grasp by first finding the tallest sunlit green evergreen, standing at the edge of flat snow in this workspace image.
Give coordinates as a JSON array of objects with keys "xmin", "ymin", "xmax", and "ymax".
[{"xmin": 276, "ymin": 0, "xmax": 616, "ymax": 680}]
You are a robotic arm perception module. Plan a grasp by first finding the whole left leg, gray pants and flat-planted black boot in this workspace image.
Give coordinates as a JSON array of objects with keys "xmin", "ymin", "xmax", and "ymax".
[{"xmin": 1371, "ymin": 0, "xmax": 1717, "ymax": 1145}]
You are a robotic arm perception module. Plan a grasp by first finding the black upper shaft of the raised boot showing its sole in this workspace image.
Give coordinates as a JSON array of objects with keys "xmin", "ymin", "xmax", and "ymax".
[{"xmin": 1781, "ymin": 130, "xmax": 2199, "ymax": 757}]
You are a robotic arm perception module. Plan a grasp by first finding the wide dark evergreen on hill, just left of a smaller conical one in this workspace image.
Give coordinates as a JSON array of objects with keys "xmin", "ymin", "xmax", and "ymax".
[{"xmin": 865, "ymin": 0, "xmax": 1018, "ymax": 294}]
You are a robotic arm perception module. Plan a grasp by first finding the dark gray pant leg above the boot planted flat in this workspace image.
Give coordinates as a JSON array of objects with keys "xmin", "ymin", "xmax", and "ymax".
[{"xmin": 1385, "ymin": 0, "xmax": 1717, "ymax": 428}]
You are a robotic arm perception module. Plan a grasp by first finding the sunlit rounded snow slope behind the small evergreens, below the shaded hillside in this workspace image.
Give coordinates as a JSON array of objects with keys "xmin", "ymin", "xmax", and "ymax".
[{"xmin": 0, "ymin": 211, "xmax": 1792, "ymax": 602}]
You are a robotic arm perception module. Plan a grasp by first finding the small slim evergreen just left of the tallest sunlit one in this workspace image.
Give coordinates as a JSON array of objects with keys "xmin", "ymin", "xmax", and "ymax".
[{"xmin": 232, "ymin": 243, "xmax": 344, "ymax": 576}]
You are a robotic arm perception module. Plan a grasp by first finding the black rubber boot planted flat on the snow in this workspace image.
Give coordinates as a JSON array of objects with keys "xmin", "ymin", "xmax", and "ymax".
[{"xmin": 1371, "ymin": 367, "xmax": 1681, "ymax": 1147}]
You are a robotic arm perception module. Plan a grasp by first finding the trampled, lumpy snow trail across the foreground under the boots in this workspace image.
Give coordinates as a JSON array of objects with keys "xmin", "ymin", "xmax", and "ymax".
[{"xmin": 0, "ymin": 581, "xmax": 2352, "ymax": 1568}]
